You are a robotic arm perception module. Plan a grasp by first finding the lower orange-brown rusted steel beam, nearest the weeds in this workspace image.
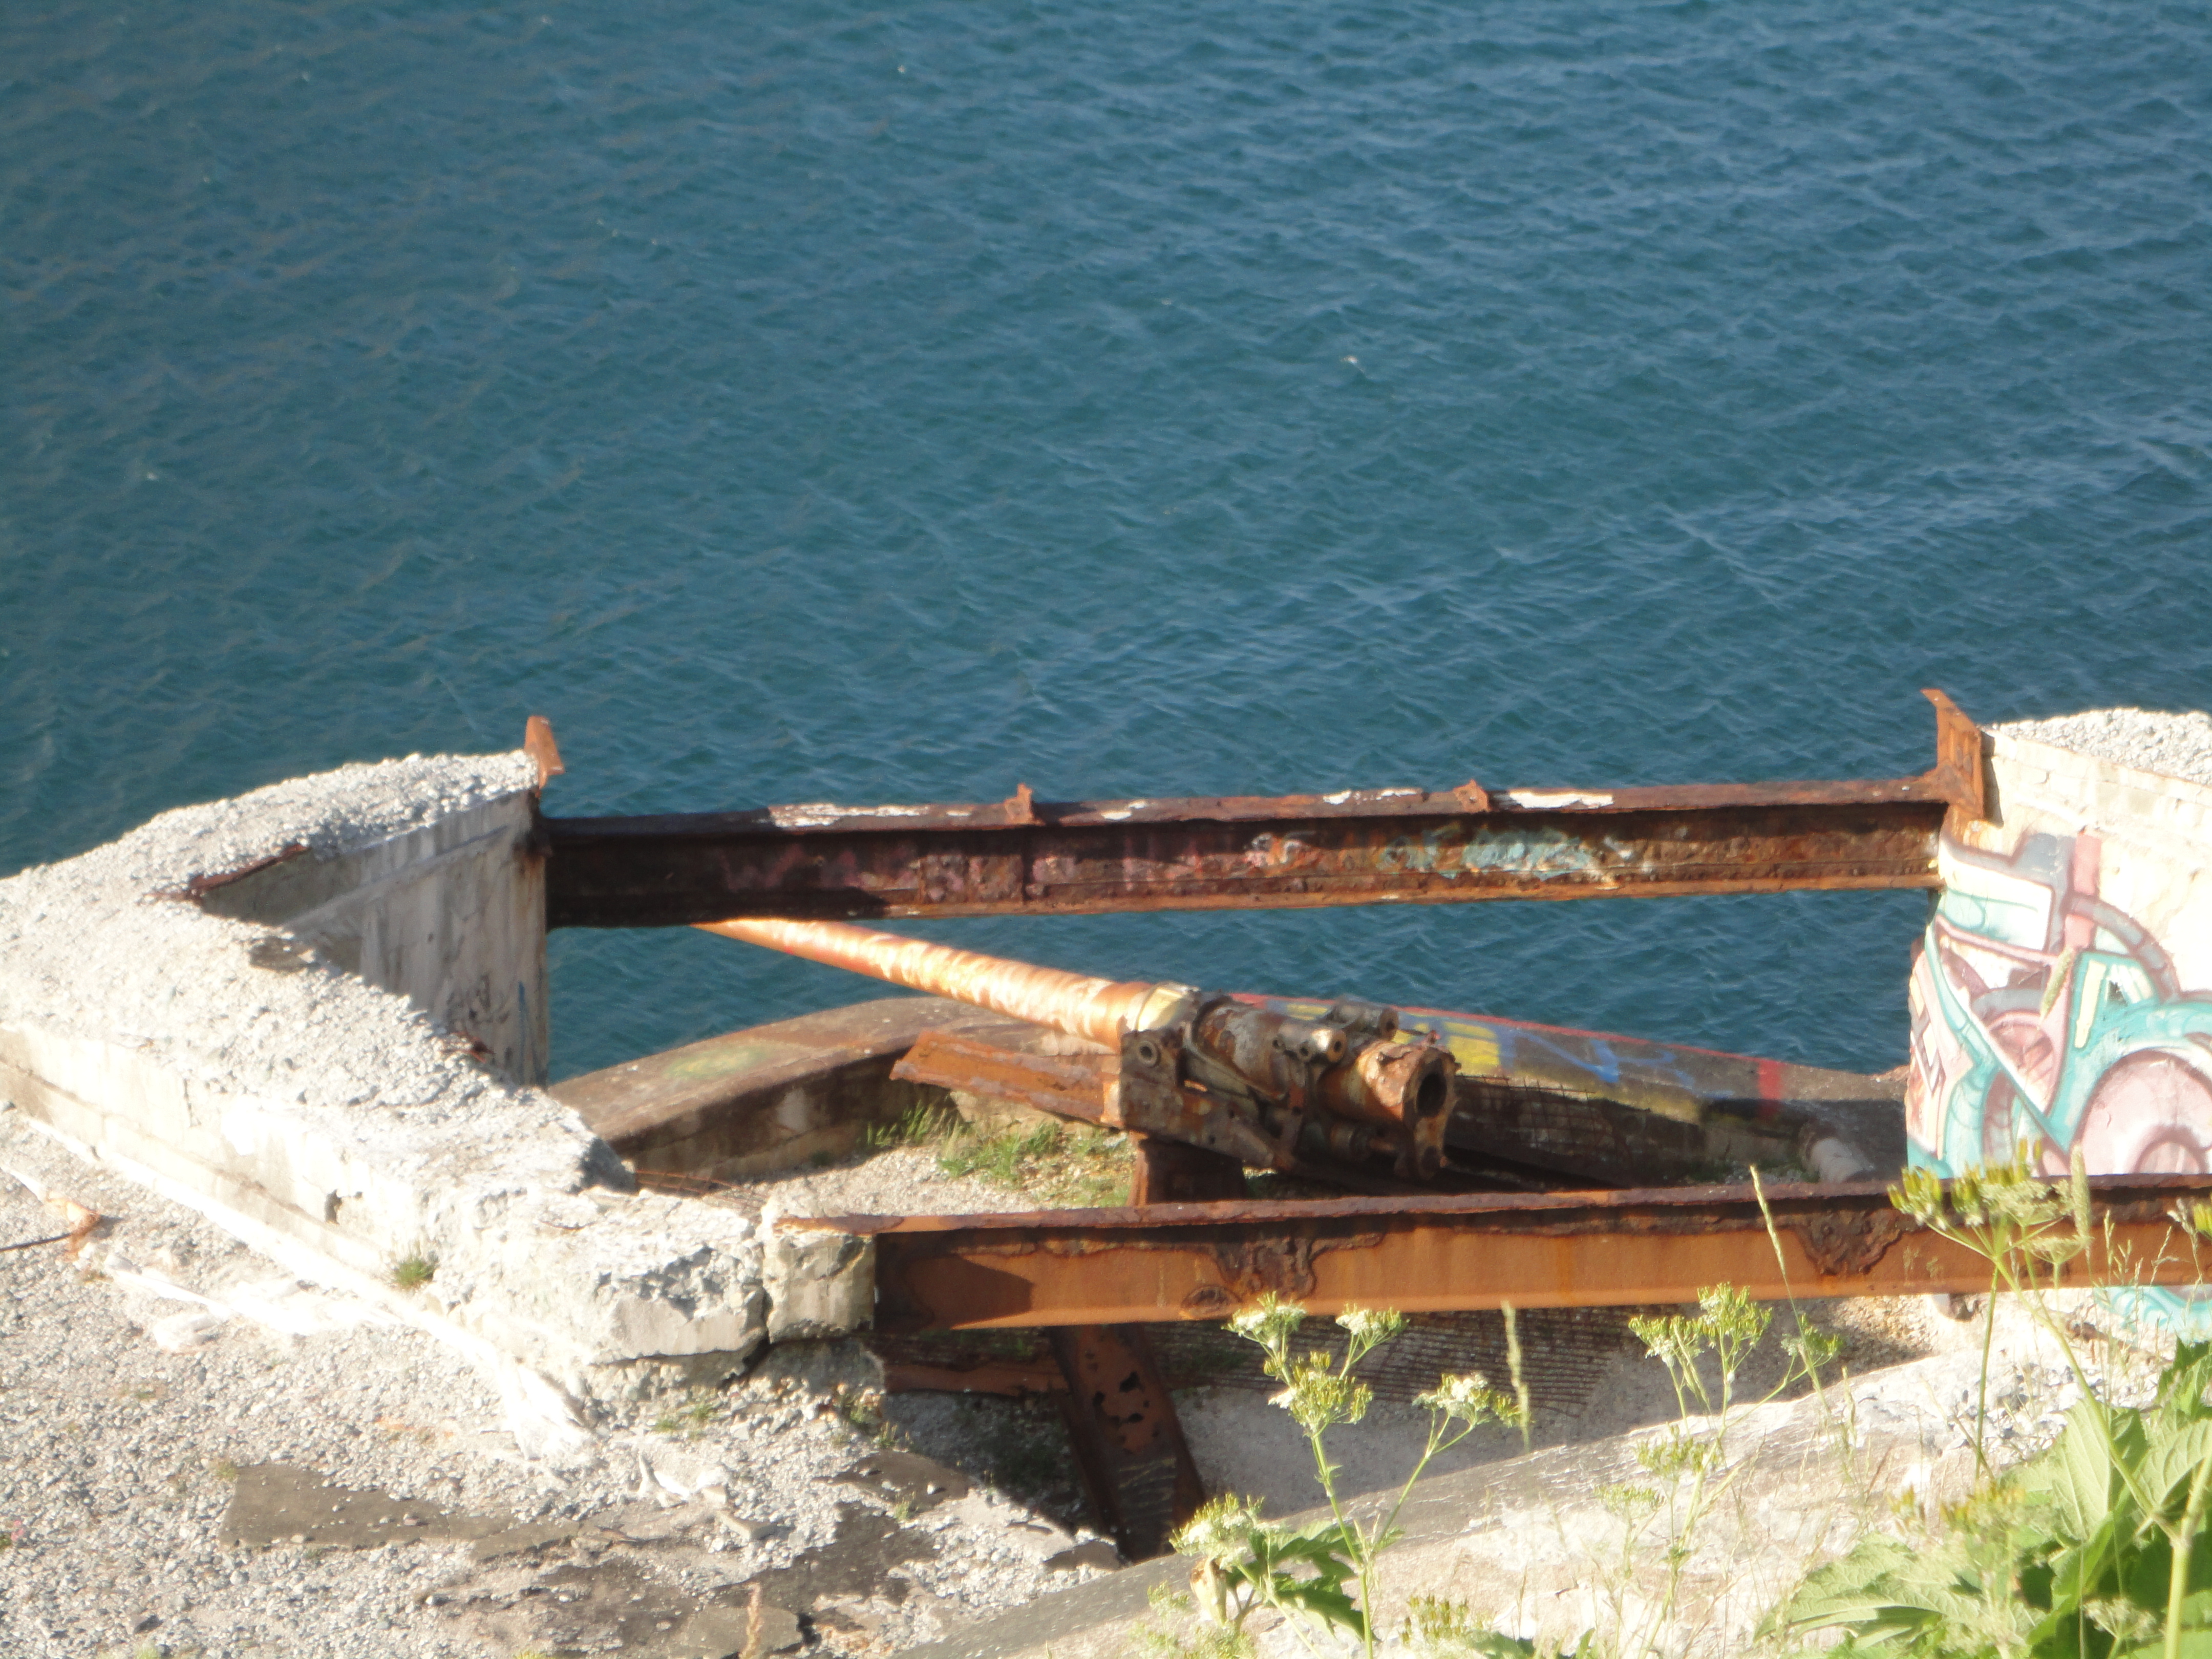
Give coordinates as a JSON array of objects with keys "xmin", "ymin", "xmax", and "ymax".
[{"xmin": 781, "ymin": 1175, "xmax": 2207, "ymax": 1334}]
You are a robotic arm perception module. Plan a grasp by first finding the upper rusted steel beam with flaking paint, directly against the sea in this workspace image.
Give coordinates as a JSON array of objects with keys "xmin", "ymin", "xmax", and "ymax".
[{"xmin": 542, "ymin": 692, "xmax": 1982, "ymax": 927}]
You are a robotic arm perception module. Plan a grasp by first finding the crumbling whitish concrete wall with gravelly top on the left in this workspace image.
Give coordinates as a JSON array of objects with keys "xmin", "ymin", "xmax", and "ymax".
[{"xmin": 0, "ymin": 754, "xmax": 869, "ymax": 1433}]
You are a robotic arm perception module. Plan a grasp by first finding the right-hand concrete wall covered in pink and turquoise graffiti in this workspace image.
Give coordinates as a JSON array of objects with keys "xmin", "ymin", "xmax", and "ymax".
[{"xmin": 1905, "ymin": 717, "xmax": 2212, "ymax": 1173}]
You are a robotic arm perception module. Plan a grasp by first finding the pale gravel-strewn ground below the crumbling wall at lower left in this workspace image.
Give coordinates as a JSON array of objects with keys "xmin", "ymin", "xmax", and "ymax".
[{"xmin": 0, "ymin": 1111, "xmax": 1123, "ymax": 1659}]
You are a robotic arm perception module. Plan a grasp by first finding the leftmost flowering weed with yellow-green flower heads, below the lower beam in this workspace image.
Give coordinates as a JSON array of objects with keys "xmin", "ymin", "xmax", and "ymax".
[{"xmin": 1175, "ymin": 1296, "xmax": 1522, "ymax": 1659}]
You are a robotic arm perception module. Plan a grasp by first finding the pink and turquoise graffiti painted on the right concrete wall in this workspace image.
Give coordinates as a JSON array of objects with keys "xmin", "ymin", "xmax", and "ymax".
[{"xmin": 1905, "ymin": 832, "xmax": 2212, "ymax": 1175}]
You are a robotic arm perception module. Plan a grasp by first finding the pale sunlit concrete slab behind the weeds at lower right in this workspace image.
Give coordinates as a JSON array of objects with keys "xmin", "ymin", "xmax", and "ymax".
[{"xmin": 905, "ymin": 1296, "xmax": 2097, "ymax": 1659}]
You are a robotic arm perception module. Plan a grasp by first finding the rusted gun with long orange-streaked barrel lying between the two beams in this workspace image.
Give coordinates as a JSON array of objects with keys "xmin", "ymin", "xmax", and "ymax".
[{"xmin": 697, "ymin": 918, "xmax": 1458, "ymax": 1181}]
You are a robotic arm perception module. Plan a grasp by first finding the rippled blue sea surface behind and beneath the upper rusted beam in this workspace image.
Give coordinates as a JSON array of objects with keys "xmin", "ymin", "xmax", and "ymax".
[{"xmin": 0, "ymin": 0, "xmax": 2212, "ymax": 1075}]
